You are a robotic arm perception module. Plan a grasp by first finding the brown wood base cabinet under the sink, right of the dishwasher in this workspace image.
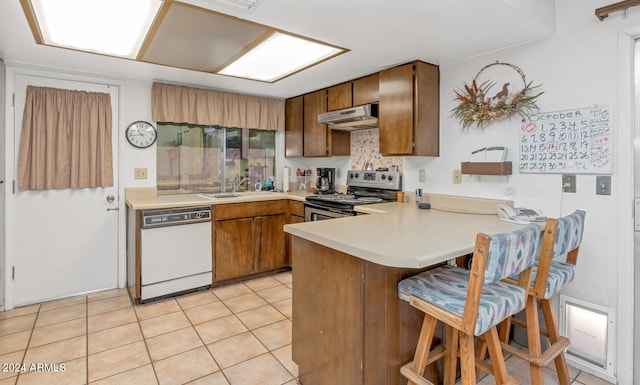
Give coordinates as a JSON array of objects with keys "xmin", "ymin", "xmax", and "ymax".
[{"xmin": 213, "ymin": 200, "xmax": 289, "ymax": 283}]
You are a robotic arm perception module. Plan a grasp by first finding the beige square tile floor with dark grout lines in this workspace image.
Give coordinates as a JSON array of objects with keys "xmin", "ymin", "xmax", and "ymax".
[{"xmin": 0, "ymin": 273, "xmax": 607, "ymax": 385}]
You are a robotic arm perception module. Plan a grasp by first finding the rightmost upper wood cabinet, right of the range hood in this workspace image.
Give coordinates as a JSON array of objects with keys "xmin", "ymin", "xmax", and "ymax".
[{"xmin": 379, "ymin": 61, "xmax": 440, "ymax": 156}]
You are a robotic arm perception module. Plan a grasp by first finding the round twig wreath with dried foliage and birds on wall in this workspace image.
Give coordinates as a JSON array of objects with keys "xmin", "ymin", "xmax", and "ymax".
[{"xmin": 451, "ymin": 61, "xmax": 544, "ymax": 132}]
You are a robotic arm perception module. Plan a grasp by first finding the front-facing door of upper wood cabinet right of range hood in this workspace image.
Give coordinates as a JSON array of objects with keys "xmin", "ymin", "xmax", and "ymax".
[{"xmin": 378, "ymin": 64, "xmax": 414, "ymax": 155}]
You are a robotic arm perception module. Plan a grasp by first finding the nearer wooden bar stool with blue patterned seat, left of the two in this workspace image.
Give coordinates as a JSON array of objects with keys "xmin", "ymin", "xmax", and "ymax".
[{"xmin": 398, "ymin": 225, "xmax": 540, "ymax": 385}]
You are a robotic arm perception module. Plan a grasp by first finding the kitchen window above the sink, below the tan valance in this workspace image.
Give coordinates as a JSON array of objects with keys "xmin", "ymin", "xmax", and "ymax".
[{"xmin": 156, "ymin": 123, "xmax": 275, "ymax": 194}]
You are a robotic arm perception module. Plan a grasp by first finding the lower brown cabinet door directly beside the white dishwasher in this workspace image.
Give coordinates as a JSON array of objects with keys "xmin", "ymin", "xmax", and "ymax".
[{"xmin": 215, "ymin": 218, "xmax": 255, "ymax": 281}]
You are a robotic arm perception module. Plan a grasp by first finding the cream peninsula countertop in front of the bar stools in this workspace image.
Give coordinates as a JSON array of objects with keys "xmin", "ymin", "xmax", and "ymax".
[{"xmin": 284, "ymin": 203, "xmax": 522, "ymax": 268}]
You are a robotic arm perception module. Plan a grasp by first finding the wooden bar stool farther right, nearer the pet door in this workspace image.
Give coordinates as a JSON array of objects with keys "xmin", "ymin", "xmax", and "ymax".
[{"xmin": 500, "ymin": 210, "xmax": 585, "ymax": 385}]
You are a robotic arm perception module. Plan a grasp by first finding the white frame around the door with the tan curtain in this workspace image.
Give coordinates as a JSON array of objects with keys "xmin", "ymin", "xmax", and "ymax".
[{"xmin": 2, "ymin": 63, "xmax": 126, "ymax": 310}]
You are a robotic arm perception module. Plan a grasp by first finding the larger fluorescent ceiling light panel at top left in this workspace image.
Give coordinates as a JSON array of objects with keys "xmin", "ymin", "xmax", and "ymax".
[{"xmin": 31, "ymin": 0, "xmax": 162, "ymax": 59}]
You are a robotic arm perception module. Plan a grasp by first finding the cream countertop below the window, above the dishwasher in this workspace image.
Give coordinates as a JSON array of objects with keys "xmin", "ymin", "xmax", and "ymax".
[{"xmin": 126, "ymin": 189, "xmax": 308, "ymax": 210}]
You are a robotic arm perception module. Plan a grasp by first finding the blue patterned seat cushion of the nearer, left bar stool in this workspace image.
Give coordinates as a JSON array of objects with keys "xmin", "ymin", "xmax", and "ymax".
[{"xmin": 398, "ymin": 265, "xmax": 527, "ymax": 336}]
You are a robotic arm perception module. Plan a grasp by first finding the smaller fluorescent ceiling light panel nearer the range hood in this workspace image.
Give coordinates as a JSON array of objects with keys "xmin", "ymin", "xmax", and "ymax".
[{"xmin": 218, "ymin": 32, "xmax": 345, "ymax": 82}]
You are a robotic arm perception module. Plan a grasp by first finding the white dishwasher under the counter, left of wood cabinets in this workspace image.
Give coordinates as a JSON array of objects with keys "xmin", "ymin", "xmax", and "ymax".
[{"xmin": 140, "ymin": 207, "xmax": 213, "ymax": 302}]
